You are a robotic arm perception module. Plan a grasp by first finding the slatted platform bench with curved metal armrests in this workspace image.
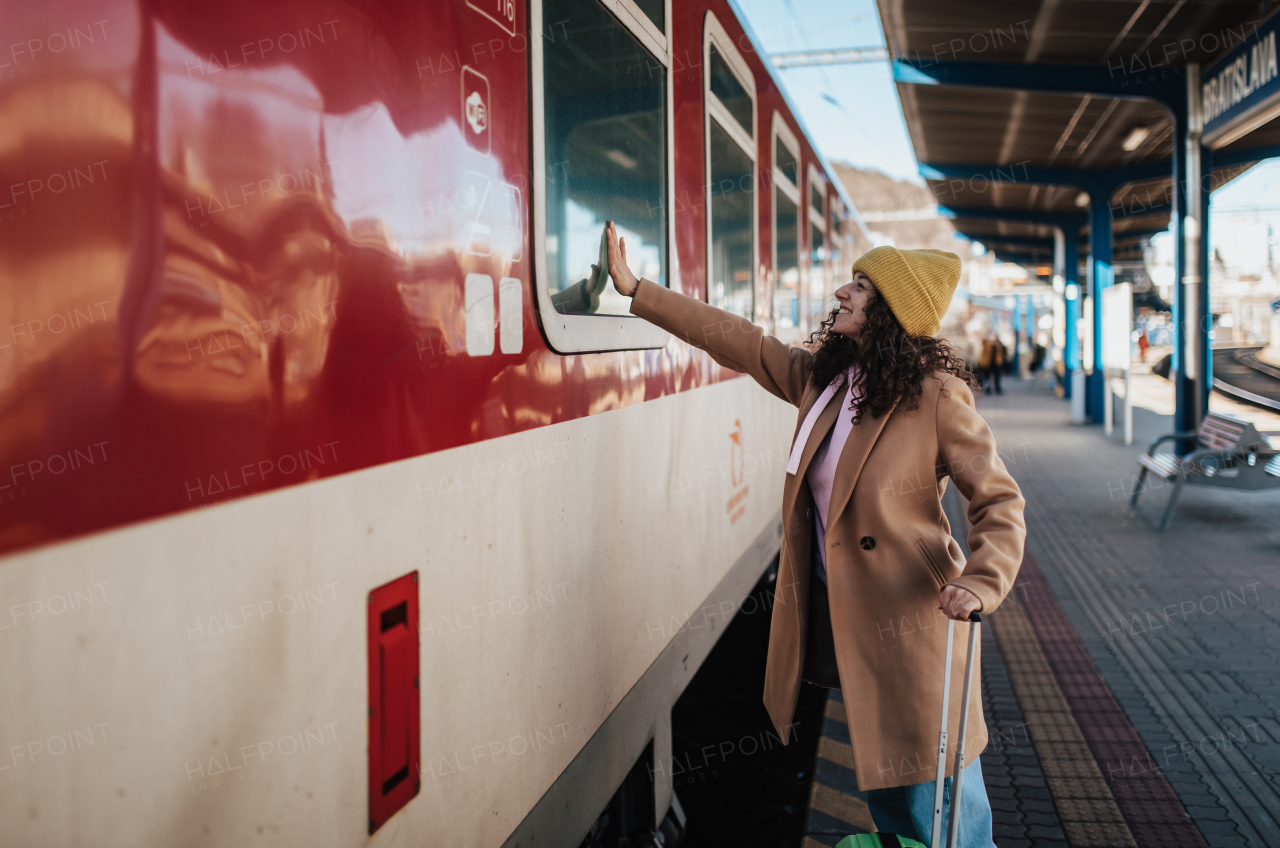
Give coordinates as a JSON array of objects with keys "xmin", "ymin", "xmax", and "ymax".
[{"xmin": 1129, "ymin": 412, "xmax": 1280, "ymax": 532}]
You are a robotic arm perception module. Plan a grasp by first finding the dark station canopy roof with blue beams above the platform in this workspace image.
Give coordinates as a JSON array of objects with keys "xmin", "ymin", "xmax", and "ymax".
[{"xmin": 878, "ymin": 0, "xmax": 1280, "ymax": 263}]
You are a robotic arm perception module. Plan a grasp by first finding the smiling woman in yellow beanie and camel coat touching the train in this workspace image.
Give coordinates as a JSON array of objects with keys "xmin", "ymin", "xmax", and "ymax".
[{"xmin": 608, "ymin": 222, "xmax": 1027, "ymax": 848}]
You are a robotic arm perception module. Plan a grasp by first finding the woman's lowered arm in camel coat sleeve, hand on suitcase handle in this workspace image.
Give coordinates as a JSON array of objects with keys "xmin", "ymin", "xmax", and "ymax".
[{"xmin": 925, "ymin": 377, "xmax": 1027, "ymax": 615}]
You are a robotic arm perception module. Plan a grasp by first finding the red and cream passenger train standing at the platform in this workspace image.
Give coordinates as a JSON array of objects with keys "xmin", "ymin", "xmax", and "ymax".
[{"xmin": 0, "ymin": 0, "xmax": 870, "ymax": 848}]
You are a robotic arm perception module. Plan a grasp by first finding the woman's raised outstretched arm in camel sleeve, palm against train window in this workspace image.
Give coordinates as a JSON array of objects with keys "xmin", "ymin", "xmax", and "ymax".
[{"xmin": 609, "ymin": 222, "xmax": 813, "ymax": 406}]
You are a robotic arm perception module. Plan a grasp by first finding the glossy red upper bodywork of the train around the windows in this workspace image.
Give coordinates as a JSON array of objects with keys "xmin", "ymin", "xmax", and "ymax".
[{"xmin": 0, "ymin": 3, "xmax": 860, "ymax": 551}]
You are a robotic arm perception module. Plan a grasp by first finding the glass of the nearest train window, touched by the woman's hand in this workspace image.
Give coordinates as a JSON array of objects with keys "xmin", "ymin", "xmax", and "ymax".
[{"xmin": 541, "ymin": 0, "xmax": 667, "ymax": 315}]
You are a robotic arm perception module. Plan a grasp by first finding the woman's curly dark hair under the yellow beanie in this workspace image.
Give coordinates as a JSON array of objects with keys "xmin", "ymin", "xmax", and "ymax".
[{"xmin": 809, "ymin": 291, "xmax": 979, "ymax": 424}]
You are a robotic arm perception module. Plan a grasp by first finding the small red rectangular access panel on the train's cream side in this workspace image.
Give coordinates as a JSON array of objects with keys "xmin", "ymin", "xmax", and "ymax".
[{"xmin": 369, "ymin": 571, "xmax": 422, "ymax": 833}]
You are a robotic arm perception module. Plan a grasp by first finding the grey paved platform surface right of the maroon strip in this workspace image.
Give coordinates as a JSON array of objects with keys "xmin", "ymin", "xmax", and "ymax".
[{"xmin": 979, "ymin": 389, "xmax": 1280, "ymax": 848}]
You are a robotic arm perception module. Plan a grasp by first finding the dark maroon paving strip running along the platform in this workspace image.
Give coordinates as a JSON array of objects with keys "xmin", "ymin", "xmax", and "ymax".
[{"xmin": 995, "ymin": 553, "xmax": 1208, "ymax": 848}]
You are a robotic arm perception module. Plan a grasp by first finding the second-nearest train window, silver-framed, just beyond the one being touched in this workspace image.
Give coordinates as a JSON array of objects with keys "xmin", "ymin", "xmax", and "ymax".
[{"xmin": 703, "ymin": 12, "xmax": 756, "ymax": 319}]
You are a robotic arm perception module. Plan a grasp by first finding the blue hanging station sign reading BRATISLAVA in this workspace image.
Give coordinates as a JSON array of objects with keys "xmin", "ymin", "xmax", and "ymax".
[{"xmin": 1201, "ymin": 15, "xmax": 1280, "ymax": 147}]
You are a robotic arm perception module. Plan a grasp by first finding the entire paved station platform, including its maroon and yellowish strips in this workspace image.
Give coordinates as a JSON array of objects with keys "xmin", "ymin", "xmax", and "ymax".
[{"xmin": 801, "ymin": 373, "xmax": 1280, "ymax": 848}]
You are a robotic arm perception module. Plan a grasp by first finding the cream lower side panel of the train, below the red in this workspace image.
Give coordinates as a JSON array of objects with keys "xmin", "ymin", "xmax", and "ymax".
[{"xmin": 0, "ymin": 379, "xmax": 795, "ymax": 848}]
